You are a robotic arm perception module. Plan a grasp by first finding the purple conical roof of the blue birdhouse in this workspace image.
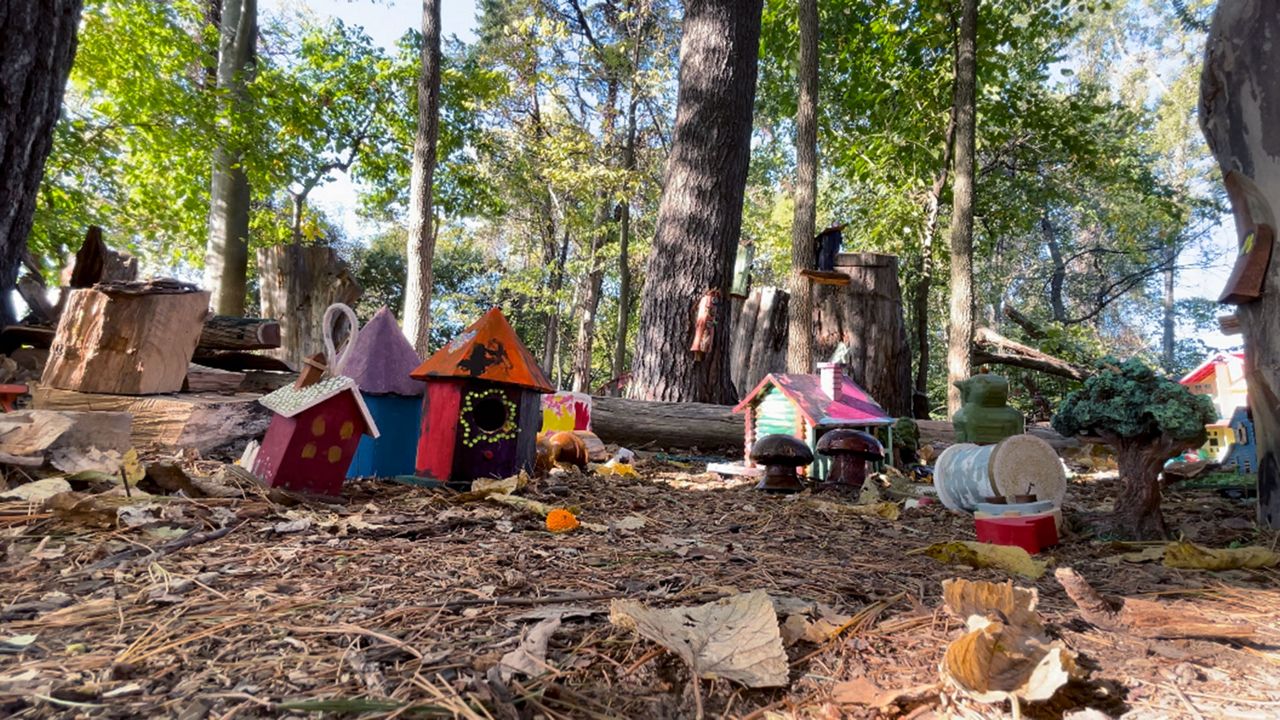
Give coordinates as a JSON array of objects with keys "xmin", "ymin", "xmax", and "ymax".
[{"xmin": 342, "ymin": 307, "xmax": 422, "ymax": 397}]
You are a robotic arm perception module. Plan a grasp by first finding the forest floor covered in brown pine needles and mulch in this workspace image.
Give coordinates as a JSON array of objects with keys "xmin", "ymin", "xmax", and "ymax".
[{"xmin": 0, "ymin": 457, "xmax": 1280, "ymax": 719}]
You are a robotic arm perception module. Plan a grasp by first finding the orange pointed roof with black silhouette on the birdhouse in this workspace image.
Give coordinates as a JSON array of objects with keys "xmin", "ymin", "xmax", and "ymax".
[{"xmin": 412, "ymin": 307, "xmax": 554, "ymax": 392}]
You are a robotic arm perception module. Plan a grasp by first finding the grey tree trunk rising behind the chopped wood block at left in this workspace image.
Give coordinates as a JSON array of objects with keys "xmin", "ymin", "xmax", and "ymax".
[{"xmin": 205, "ymin": 0, "xmax": 257, "ymax": 315}]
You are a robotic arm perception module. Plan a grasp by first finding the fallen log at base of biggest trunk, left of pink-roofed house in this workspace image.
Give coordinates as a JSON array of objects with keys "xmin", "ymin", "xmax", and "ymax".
[{"xmin": 591, "ymin": 396, "xmax": 744, "ymax": 455}]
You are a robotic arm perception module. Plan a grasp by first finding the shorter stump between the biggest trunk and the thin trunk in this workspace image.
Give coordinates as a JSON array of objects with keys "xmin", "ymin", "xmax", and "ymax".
[{"xmin": 730, "ymin": 287, "xmax": 788, "ymax": 400}]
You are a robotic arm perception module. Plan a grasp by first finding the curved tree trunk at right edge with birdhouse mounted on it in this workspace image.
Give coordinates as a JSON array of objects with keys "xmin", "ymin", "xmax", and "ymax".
[{"xmin": 1199, "ymin": 0, "xmax": 1280, "ymax": 528}]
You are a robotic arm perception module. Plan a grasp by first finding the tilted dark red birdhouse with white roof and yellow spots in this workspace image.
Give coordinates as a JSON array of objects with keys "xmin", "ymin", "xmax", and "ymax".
[{"xmin": 252, "ymin": 373, "xmax": 378, "ymax": 496}]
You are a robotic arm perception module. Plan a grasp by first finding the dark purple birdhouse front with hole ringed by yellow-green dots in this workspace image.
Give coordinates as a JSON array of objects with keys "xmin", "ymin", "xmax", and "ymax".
[{"xmin": 452, "ymin": 383, "xmax": 524, "ymax": 482}]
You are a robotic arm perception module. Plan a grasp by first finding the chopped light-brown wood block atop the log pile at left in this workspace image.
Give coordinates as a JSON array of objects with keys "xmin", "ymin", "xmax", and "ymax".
[{"xmin": 41, "ymin": 281, "xmax": 209, "ymax": 395}]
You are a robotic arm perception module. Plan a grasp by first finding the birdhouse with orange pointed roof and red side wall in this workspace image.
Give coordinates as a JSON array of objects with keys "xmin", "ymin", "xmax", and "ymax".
[{"xmin": 412, "ymin": 307, "xmax": 553, "ymax": 486}]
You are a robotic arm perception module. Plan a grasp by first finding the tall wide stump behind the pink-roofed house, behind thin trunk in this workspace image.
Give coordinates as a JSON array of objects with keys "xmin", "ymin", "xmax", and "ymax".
[{"xmin": 814, "ymin": 252, "xmax": 911, "ymax": 418}]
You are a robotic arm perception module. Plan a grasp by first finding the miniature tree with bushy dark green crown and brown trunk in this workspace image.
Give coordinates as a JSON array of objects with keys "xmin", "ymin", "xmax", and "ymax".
[{"xmin": 1053, "ymin": 360, "xmax": 1217, "ymax": 539}]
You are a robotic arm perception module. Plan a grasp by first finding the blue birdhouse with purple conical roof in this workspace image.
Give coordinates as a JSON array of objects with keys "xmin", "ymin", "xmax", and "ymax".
[{"xmin": 342, "ymin": 307, "xmax": 424, "ymax": 478}]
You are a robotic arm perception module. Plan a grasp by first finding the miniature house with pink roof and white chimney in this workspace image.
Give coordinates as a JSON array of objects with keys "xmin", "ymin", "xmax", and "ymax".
[{"xmin": 733, "ymin": 363, "xmax": 893, "ymax": 480}]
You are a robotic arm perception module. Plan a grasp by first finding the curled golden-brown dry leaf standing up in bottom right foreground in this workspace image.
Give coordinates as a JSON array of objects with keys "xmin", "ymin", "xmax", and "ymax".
[{"xmin": 942, "ymin": 579, "xmax": 1082, "ymax": 702}]
